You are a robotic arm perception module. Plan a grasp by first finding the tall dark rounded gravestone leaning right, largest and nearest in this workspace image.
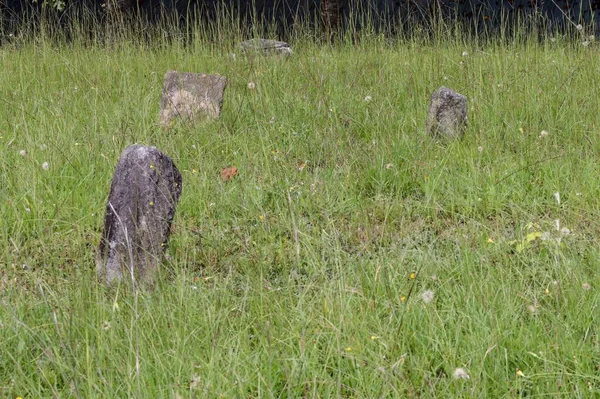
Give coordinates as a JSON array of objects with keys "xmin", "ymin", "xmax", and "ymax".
[{"xmin": 96, "ymin": 145, "xmax": 182, "ymax": 283}]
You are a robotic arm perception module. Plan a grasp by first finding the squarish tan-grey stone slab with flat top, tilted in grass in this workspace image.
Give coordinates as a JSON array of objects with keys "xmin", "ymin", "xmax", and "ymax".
[{"xmin": 160, "ymin": 71, "xmax": 227, "ymax": 126}]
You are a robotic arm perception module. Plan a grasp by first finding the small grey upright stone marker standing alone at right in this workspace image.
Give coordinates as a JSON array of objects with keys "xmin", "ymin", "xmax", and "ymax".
[{"xmin": 426, "ymin": 87, "xmax": 467, "ymax": 139}]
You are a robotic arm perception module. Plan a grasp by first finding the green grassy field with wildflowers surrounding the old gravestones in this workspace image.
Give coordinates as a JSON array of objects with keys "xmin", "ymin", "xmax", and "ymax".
[{"xmin": 0, "ymin": 22, "xmax": 600, "ymax": 398}]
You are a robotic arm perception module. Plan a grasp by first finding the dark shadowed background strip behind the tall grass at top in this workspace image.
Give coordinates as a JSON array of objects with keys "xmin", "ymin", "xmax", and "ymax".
[{"xmin": 0, "ymin": 0, "xmax": 600, "ymax": 39}]
